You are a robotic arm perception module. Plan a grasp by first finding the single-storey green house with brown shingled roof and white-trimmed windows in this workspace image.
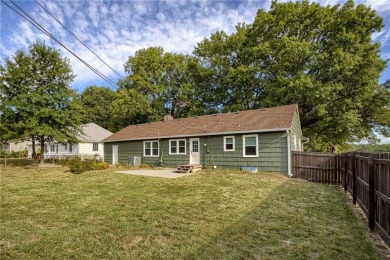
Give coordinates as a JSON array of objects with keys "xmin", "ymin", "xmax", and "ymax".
[{"xmin": 103, "ymin": 105, "xmax": 304, "ymax": 174}]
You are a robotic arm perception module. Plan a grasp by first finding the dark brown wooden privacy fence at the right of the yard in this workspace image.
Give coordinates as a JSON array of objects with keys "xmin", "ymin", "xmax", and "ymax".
[{"xmin": 292, "ymin": 152, "xmax": 390, "ymax": 245}]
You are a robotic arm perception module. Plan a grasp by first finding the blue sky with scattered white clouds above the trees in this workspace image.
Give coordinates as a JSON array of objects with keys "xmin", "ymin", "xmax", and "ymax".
[{"xmin": 0, "ymin": 0, "xmax": 390, "ymax": 142}]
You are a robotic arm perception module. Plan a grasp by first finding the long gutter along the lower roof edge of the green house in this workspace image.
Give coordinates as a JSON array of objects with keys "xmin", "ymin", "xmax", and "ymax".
[{"xmin": 102, "ymin": 128, "xmax": 290, "ymax": 143}]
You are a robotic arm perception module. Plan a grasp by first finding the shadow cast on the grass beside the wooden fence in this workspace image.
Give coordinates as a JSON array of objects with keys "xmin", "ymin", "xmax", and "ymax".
[{"xmin": 184, "ymin": 180, "xmax": 380, "ymax": 259}]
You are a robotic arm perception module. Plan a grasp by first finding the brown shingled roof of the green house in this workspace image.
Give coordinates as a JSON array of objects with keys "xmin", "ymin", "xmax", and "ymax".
[{"xmin": 103, "ymin": 104, "xmax": 298, "ymax": 142}]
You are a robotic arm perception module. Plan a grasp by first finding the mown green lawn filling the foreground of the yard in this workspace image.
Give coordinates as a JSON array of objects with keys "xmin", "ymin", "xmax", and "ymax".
[{"xmin": 0, "ymin": 167, "xmax": 381, "ymax": 259}]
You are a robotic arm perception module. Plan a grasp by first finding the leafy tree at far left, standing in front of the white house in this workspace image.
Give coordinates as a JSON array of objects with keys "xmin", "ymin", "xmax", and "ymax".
[{"xmin": 0, "ymin": 42, "xmax": 80, "ymax": 162}]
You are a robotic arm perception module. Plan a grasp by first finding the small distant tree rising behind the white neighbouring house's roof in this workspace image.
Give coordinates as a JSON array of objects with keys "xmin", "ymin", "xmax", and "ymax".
[{"xmin": 80, "ymin": 86, "xmax": 116, "ymax": 131}]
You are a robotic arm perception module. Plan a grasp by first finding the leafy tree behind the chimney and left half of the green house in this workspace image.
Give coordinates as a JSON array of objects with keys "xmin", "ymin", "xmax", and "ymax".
[{"xmin": 118, "ymin": 47, "xmax": 198, "ymax": 124}]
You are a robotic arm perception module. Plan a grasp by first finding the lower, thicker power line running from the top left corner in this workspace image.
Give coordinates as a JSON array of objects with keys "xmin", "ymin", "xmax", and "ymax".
[{"xmin": 1, "ymin": 0, "xmax": 117, "ymax": 88}]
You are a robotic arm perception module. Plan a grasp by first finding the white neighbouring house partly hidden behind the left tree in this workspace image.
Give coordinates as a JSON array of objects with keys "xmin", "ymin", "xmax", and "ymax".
[{"xmin": 28, "ymin": 123, "xmax": 112, "ymax": 159}]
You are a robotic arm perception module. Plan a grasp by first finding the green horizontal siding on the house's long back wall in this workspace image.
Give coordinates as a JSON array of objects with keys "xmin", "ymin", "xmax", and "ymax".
[{"xmin": 104, "ymin": 132, "xmax": 287, "ymax": 173}]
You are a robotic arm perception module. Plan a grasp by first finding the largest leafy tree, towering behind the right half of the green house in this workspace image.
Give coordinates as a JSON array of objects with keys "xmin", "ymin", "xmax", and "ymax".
[{"xmin": 194, "ymin": 0, "xmax": 390, "ymax": 151}]
